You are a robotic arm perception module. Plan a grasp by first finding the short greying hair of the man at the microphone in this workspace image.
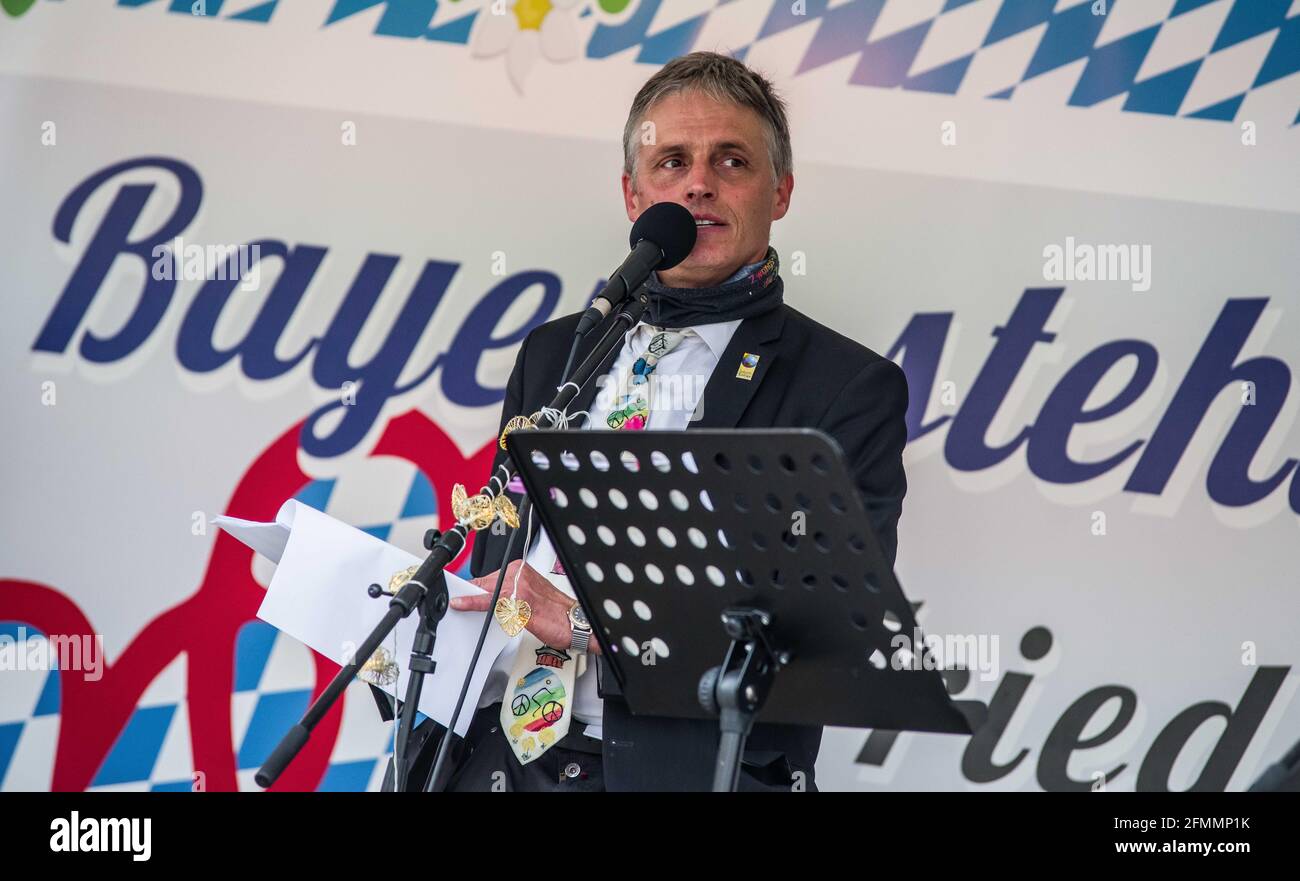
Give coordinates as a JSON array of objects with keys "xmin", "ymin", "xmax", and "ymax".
[{"xmin": 623, "ymin": 52, "xmax": 794, "ymax": 182}]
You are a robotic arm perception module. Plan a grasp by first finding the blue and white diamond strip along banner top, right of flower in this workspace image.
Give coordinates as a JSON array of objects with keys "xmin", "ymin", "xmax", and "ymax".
[{"xmin": 588, "ymin": 0, "xmax": 1300, "ymax": 125}]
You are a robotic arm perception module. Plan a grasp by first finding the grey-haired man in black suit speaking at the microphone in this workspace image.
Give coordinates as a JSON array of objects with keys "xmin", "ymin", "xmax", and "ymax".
[{"xmin": 390, "ymin": 52, "xmax": 907, "ymax": 790}]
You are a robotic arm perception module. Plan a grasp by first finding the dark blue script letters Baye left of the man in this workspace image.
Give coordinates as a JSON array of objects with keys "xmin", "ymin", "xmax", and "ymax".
[{"xmin": 33, "ymin": 157, "xmax": 562, "ymax": 457}]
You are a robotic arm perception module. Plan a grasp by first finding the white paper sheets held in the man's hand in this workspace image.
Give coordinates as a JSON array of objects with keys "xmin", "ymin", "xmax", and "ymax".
[{"xmin": 212, "ymin": 499, "xmax": 507, "ymax": 735}]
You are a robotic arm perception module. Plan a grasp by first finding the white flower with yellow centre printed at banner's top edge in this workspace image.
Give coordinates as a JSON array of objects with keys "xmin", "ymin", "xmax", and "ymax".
[{"xmin": 469, "ymin": 0, "xmax": 582, "ymax": 95}]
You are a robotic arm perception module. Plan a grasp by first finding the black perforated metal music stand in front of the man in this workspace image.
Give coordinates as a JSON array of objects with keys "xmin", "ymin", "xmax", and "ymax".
[{"xmin": 507, "ymin": 429, "xmax": 971, "ymax": 790}]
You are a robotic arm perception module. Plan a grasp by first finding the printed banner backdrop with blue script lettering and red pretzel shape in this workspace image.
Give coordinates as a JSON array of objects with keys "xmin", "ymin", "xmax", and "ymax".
[{"xmin": 0, "ymin": 0, "xmax": 1300, "ymax": 790}]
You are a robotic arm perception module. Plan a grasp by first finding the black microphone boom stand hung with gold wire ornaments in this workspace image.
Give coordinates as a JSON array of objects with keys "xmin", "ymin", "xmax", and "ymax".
[{"xmin": 254, "ymin": 288, "xmax": 650, "ymax": 791}]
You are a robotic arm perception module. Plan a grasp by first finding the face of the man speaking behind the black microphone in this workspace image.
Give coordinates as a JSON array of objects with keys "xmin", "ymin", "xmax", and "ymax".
[{"xmin": 623, "ymin": 91, "xmax": 794, "ymax": 287}]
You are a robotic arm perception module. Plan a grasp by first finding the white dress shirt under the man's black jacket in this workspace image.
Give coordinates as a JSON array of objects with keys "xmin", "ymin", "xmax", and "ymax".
[{"xmin": 478, "ymin": 318, "xmax": 740, "ymax": 738}]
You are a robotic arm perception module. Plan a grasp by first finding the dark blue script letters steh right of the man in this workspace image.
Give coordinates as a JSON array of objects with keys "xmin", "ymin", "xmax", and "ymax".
[{"xmin": 889, "ymin": 287, "xmax": 1300, "ymax": 513}]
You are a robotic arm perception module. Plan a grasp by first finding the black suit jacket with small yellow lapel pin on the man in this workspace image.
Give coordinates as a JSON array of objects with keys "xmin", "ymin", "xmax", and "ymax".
[{"xmin": 457, "ymin": 305, "xmax": 907, "ymax": 790}]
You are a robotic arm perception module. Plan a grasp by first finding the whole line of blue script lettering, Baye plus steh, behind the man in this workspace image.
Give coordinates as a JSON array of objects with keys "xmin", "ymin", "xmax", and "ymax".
[{"xmin": 33, "ymin": 156, "xmax": 1300, "ymax": 513}]
